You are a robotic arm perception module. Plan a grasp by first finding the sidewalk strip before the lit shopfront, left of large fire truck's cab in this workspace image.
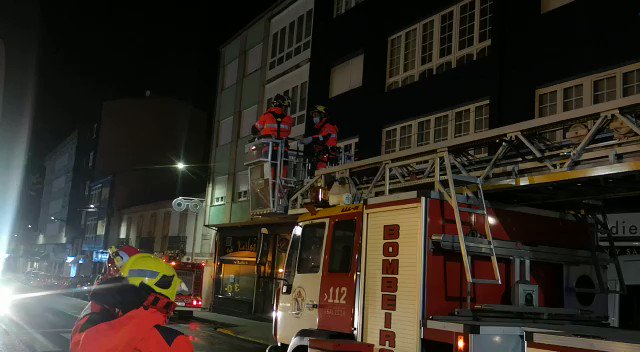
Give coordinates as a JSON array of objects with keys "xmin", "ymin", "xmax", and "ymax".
[{"xmin": 193, "ymin": 311, "xmax": 275, "ymax": 345}]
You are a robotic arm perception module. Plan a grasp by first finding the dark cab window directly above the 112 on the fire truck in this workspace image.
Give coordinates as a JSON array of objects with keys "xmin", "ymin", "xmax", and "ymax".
[{"xmin": 328, "ymin": 220, "xmax": 356, "ymax": 274}]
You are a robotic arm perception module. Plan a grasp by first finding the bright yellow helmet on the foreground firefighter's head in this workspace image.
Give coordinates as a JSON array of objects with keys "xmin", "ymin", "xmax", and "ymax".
[{"xmin": 120, "ymin": 253, "xmax": 182, "ymax": 301}]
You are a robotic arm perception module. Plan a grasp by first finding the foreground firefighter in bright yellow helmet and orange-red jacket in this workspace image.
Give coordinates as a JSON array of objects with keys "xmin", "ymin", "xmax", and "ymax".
[{"xmin": 71, "ymin": 253, "xmax": 193, "ymax": 352}]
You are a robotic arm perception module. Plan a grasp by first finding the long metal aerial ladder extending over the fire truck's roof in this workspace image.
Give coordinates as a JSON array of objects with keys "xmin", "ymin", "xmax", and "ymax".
[{"xmin": 288, "ymin": 95, "xmax": 640, "ymax": 293}]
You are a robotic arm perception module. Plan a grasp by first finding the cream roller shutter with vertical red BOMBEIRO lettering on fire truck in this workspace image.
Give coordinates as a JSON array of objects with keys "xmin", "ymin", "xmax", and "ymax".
[{"xmin": 362, "ymin": 199, "xmax": 424, "ymax": 352}]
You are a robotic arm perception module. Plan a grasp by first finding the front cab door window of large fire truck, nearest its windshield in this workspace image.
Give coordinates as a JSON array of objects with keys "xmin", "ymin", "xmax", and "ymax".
[{"xmin": 296, "ymin": 222, "xmax": 326, "ymax": 274}]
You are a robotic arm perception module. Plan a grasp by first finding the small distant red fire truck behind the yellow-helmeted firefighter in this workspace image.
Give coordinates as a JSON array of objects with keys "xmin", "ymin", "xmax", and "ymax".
[{"xmin": 169, "ymin": 261, "xmax": 205, "ymax": 316}]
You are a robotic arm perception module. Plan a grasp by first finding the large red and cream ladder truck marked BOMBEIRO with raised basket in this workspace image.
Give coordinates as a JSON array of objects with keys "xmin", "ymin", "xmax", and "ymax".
[{"xmin": 246, "ymin": 96, "xmax": 640, "ymax": 352}]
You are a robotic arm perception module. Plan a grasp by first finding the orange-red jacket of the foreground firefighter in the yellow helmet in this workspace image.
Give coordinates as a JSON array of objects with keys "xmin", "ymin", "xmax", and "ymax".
[{"xmin": 70, "ymin": 278, "xmax": 193, "ymax": 352}]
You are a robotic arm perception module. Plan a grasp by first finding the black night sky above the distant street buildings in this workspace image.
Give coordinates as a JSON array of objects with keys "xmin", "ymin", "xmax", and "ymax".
[{"xmin": 21, "ymin": 0, "xmax": 275, "ymax": 226}]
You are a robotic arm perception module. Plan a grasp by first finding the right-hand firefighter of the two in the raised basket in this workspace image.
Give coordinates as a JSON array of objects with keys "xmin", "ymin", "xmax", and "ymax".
[{"xmin": 302, "ymin": 105, "xmax": 339, "ymax": 170}]
